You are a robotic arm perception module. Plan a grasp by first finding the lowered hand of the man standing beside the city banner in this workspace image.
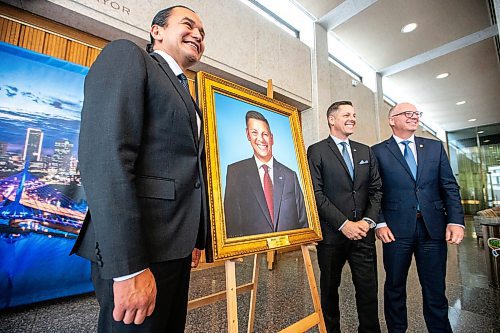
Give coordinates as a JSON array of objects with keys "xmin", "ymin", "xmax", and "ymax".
[{"xmin": 113, "ymin": 268, "xmax": 156, "ymax": 325}]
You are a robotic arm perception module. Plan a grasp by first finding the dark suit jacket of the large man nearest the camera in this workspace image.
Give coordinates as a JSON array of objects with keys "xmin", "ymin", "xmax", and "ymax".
[{"xmin": 72, "ymin": 40, "xmax": 206, "ymax": 278}]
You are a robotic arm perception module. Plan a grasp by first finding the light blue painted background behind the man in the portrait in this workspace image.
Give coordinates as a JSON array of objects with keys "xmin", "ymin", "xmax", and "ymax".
[{"xmin": 215, "ymin": 92, "xmax": 302, "ymax": 196}]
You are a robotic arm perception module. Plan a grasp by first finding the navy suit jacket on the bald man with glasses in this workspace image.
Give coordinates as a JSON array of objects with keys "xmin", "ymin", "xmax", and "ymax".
[{"xmin": 372, "ymin": 136, "xmax": 464, "ymax": 239}]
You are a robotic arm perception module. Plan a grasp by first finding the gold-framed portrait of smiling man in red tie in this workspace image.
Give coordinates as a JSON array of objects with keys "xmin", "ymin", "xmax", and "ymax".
[{"xmin": 197, "ymin": 72, "xmax": 322, "ymax": 261}]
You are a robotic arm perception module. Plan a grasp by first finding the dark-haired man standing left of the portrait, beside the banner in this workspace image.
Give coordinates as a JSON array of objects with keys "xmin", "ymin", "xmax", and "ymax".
[{"xmin": 72, "ymin": 6, "xmax": 206, "ymax": 332}]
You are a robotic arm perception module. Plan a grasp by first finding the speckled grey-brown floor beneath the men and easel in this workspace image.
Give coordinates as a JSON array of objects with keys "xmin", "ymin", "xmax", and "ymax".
[{"xmin": 0, "ymin": 218, "xmax": 500, "ymax": 333}]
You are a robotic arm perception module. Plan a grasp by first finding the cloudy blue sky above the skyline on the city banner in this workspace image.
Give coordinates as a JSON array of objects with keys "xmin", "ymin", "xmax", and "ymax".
[{"xmin": 0, "ymin": 42, "xmax": 88, "ymax": 156}]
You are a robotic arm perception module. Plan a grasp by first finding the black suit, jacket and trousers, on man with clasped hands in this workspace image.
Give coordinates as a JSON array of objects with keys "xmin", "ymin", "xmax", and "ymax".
[{"xmin": 307, "ymin": 136, "xmax": 382, "ymax": 332}]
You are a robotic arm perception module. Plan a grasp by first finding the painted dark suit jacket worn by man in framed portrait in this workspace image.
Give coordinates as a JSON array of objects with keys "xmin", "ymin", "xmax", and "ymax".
[{"xmin": 224, "ymin": 157, "xmax": 308, "ymax": 237}]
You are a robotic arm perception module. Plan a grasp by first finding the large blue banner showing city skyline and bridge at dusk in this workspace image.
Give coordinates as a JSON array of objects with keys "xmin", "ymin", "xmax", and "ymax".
[{"xmin": 0, "ymin": 42, "xmax": 93, "ymax": 309}]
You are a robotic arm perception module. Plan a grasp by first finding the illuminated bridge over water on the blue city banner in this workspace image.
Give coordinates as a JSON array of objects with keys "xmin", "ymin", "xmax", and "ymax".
[{"xmin": 0, "ymin": 161, "xmax": 87, "ymax": 234}]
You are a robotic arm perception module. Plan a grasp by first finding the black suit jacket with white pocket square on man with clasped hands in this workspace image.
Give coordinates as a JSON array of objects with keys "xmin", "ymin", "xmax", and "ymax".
[{"xmin": 307, "ymin": 136, "xmax": 382, "ymax": 244}]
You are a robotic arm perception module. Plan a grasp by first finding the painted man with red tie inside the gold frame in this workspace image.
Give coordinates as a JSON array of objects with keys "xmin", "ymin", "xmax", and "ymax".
[{"xmin": 224, "ymin": 111, "xmax": 308, "ymax": 237}]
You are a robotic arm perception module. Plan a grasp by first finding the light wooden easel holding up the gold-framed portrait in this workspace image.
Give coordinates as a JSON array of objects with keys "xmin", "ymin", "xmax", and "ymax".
[{"xmin": 188, "ymin": 80, "xmax": 326, "ymax": 333}]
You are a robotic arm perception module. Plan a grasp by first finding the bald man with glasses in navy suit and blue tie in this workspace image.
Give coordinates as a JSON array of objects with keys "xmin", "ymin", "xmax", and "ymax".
[{"xmin": 372, "ymin": 103, "xmax": 464, "ymax": 333}]
